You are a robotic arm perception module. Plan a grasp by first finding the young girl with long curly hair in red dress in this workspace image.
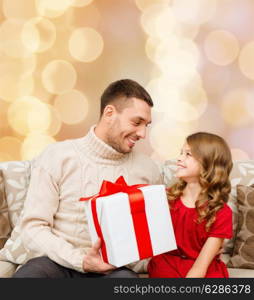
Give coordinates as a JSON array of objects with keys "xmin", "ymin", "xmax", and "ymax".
[{"xmin": 148, "ymin": 132, "xmax": 233, "ymax": 278}]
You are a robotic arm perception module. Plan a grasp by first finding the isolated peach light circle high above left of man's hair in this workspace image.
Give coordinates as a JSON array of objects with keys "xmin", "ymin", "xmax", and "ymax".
[{"xmin": 69, "ymin": 27, "xmax": 103, "ymax": 62}]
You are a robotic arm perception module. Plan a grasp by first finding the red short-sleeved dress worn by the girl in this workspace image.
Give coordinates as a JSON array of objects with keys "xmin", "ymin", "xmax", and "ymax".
[{"xmin": 148, "ymin": 199, "xmax": 233, "ymax": 278}]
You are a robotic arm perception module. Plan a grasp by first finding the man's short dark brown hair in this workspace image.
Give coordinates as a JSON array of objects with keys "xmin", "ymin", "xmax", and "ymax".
[{"xmin": 100, "ymin": 79, "xmax": 153, "ymax": 116}]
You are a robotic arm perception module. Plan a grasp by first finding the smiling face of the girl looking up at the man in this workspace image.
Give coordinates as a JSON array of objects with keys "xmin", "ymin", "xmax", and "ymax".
[{"xmin": 176, "ymin": 143, "xmax": 200, "ymax": 182}]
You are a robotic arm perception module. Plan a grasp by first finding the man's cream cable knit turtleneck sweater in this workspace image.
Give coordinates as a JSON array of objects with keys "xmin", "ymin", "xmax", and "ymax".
[{"xmin": 21, "ymin": 126, "xmax": 162, "ymax": 272}]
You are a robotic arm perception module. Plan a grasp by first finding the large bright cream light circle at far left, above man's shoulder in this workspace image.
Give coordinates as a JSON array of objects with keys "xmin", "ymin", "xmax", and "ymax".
[{"xmin": 8, "ymin": 96, "xmax": 51, "ymax": 135}]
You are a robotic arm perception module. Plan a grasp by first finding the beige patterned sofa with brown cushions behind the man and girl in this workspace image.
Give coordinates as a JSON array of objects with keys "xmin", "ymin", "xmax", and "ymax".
[{"xmin": 0, "ymin": 160, "xmax": 254, "ymax": 278}]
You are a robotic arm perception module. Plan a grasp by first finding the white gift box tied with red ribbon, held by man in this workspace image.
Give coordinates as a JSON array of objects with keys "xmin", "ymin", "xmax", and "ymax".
[{"xmin": 83, "ymin": 185, "xmax": 177, "ymax": 267}]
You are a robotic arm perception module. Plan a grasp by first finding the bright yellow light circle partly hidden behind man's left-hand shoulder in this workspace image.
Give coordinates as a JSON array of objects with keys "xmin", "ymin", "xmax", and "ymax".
[{"xmin": 21, "ymin": 133, "xmax": 56, "ymax": 160}]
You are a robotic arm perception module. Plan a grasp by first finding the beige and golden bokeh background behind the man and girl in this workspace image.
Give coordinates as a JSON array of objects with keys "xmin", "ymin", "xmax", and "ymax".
[{"xmin": 0, "ymin": 0, "xmax": 254, "ymax": 161}]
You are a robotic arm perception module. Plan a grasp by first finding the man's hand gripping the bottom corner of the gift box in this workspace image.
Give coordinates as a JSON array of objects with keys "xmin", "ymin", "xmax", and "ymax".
[{"xmin": 83, "ymin": 239, "xmax": 116, "ymax": 273}]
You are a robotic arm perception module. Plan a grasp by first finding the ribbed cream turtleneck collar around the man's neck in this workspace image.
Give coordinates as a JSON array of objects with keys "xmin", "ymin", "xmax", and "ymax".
[{"xmin": 82, "ymin": 125, "xmax": 129, "ymax": 164}]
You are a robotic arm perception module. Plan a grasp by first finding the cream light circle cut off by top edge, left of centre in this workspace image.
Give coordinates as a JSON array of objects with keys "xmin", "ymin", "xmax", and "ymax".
[{"xmin": 35, "ymin": 0, "xmax": 73, "ymax": 18}]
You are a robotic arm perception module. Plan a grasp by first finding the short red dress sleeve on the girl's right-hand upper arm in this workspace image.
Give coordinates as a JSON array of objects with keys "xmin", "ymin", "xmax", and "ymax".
[{"xmin": 208, "ymin": 204, "xmax": 233, "ymax": 239}]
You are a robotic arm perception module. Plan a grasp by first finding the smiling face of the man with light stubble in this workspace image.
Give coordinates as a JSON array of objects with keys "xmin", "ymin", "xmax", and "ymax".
[{"xmin": 106, "ymin": 98, "xmax": 151, "ymax": 153}]
